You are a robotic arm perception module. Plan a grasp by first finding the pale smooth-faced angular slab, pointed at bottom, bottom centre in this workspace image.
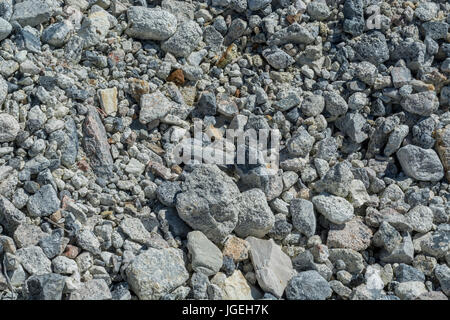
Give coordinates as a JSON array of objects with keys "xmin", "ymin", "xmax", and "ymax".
[{"xmin": 245, "ymin": 237, "xmax": 295, "ymax": 298}]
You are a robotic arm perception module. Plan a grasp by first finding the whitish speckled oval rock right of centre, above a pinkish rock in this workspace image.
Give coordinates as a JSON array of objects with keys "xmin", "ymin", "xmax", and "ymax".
[{"xmin": 312, "ymin": 194, "xmax": 354, "ymax": 224}]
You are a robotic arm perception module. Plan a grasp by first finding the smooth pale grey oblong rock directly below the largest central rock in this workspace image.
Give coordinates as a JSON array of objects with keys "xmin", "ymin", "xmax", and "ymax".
[{"xmin": 187, "ymin": 231, "xmax": 223, "ymax": 276}]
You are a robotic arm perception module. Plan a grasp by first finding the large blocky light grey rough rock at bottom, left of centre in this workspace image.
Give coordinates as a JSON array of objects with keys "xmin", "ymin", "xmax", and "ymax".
[{"xmin": 126, "ymin": 248, "xmax": 189, "ymax": 300}]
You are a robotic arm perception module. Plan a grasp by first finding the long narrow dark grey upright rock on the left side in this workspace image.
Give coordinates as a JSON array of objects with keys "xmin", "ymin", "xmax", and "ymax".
[{"xmin": 83, "ymin": 107, "xmax": 113, "ymax": 178}]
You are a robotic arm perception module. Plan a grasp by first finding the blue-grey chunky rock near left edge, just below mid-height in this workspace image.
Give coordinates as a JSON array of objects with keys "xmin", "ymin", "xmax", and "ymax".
[{"xmin": 27, "ymin": 184, "xmax": 61, "ymax": 217}]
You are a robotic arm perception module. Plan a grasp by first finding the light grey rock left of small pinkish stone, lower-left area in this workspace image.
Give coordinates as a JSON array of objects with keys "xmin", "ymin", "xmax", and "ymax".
[{"xmin": 15, "ymin": 246, "xmax": 52, "ymax": 275}]
